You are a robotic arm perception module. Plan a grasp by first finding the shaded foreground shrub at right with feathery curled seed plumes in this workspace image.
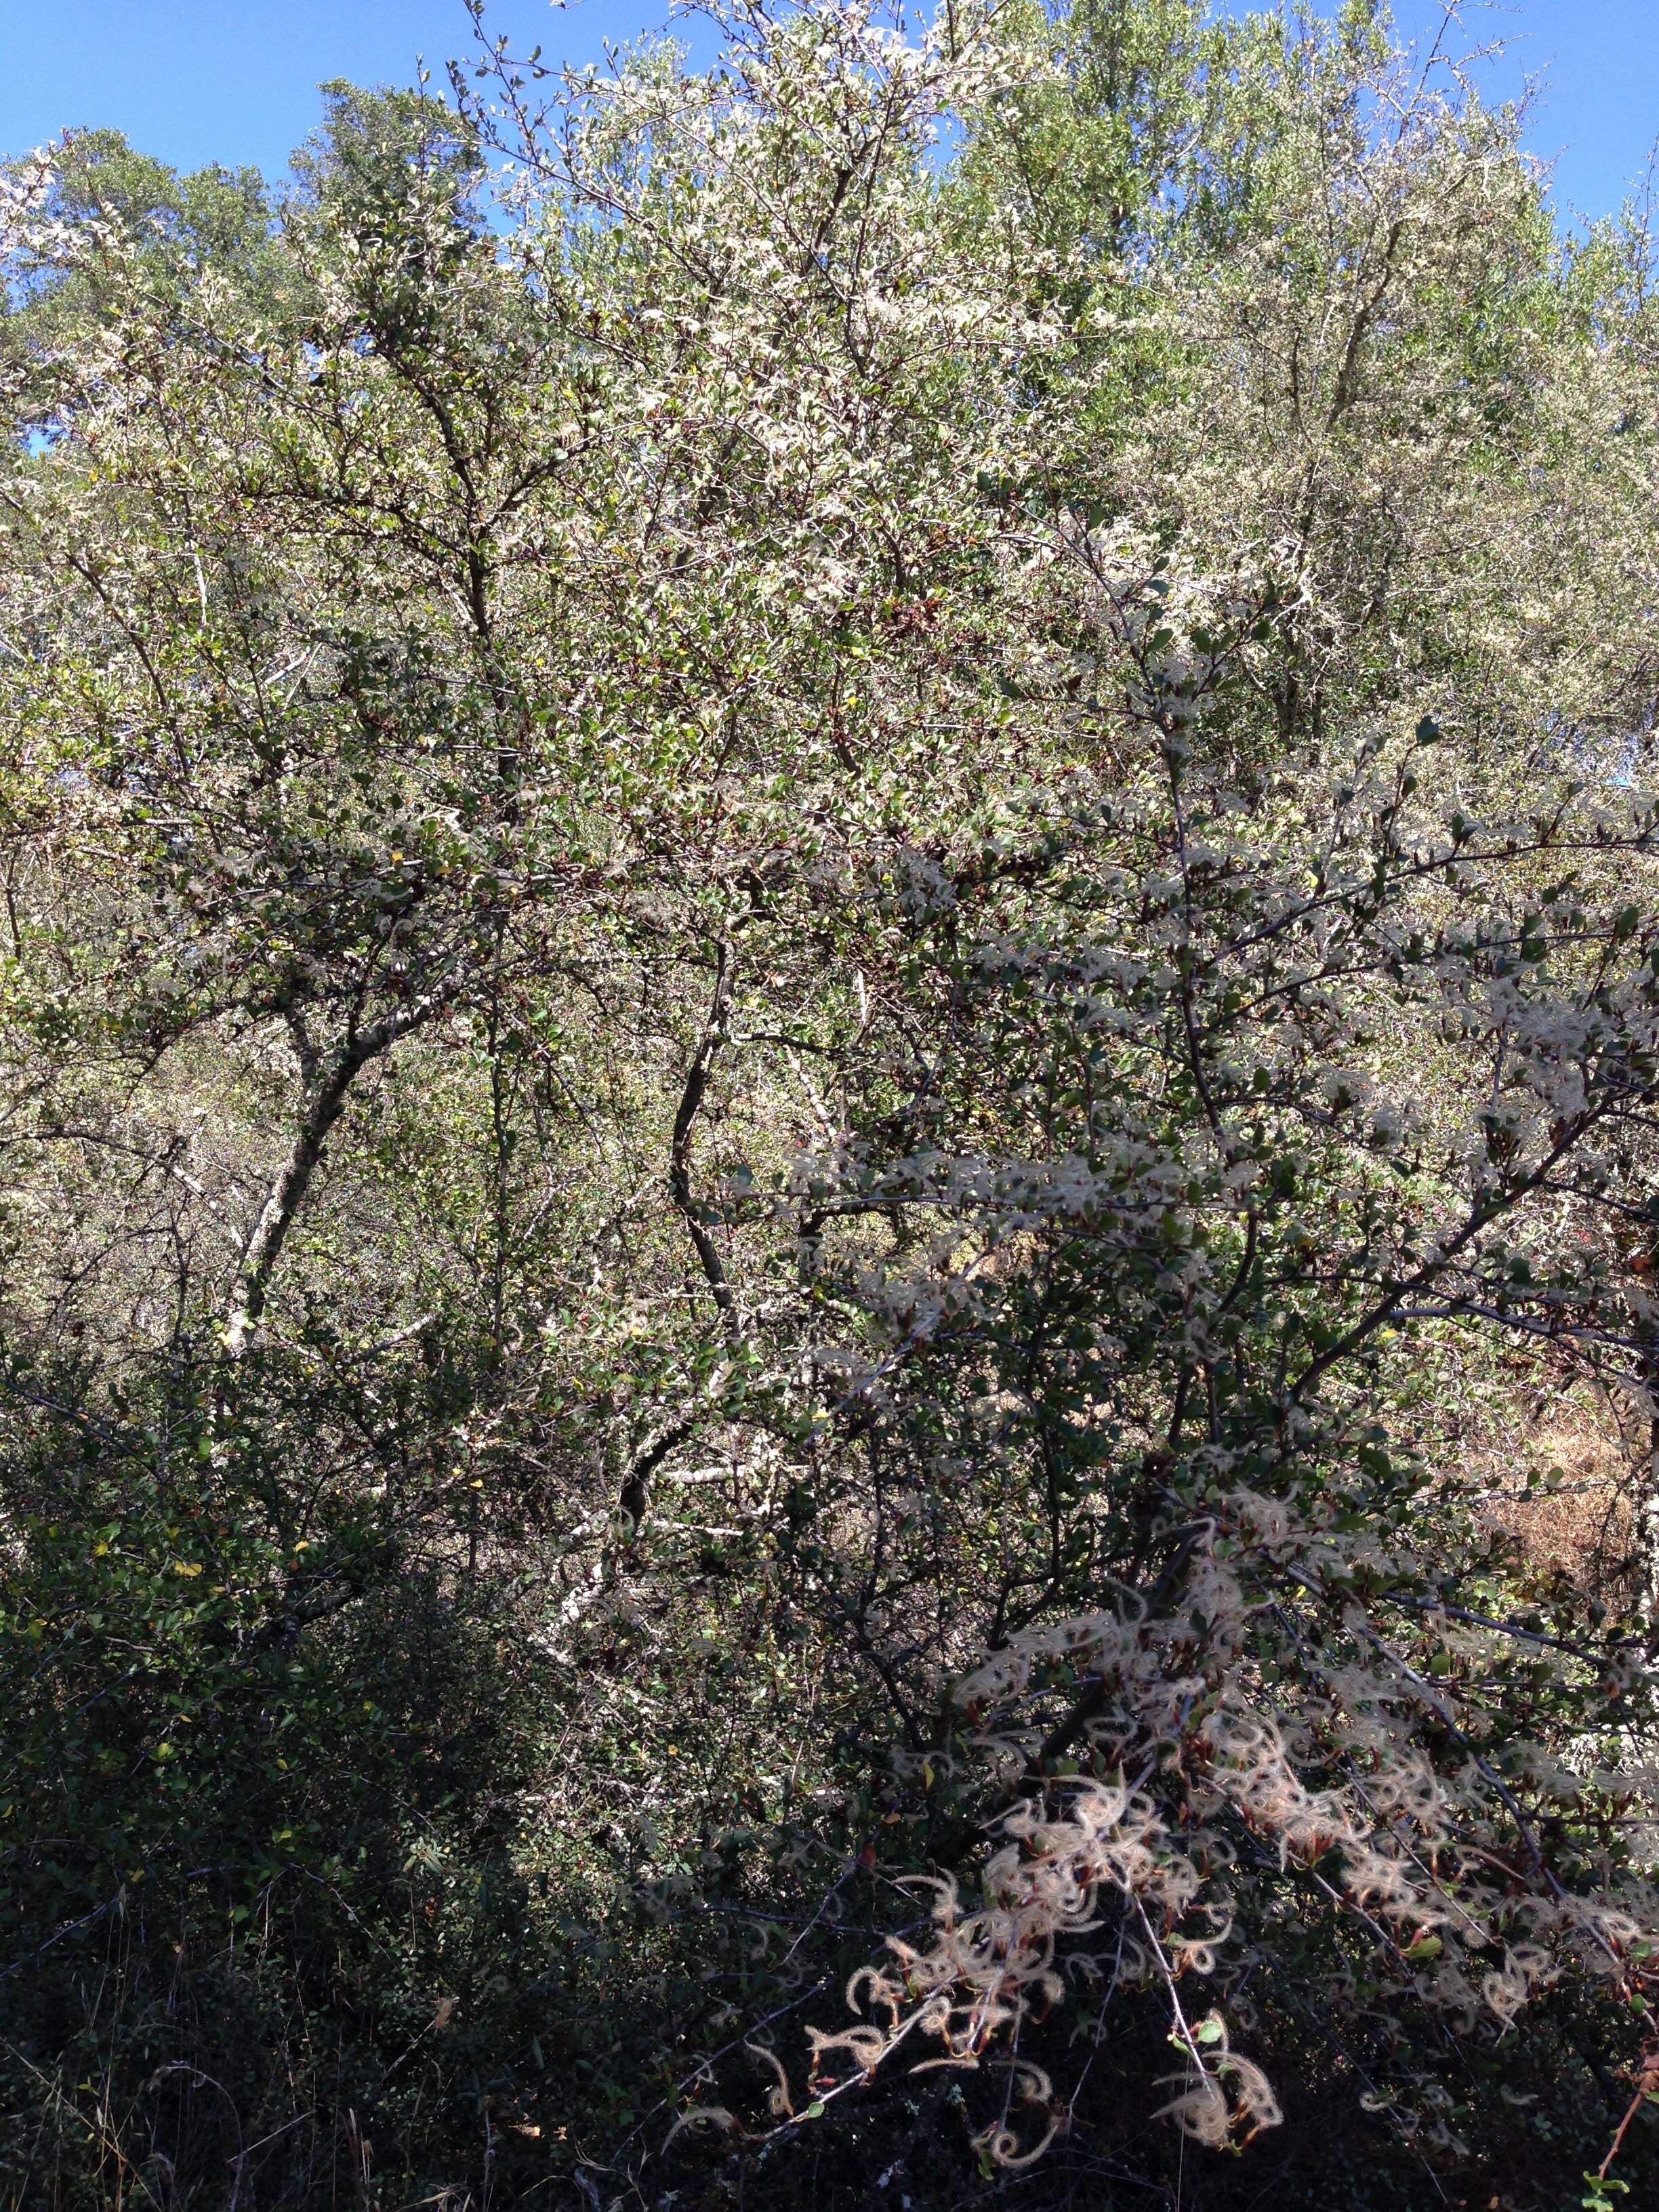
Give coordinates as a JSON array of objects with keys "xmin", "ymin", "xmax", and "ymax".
[{"xmin": 743, "ymin": 588, "xmax": 1659, "ymax": 2163}]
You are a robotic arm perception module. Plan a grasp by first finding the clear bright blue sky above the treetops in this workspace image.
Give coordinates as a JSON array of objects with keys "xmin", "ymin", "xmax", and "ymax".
[{"xmin": 0, "ymin": 0, "xmax": 1659, "ymax": 215}]
